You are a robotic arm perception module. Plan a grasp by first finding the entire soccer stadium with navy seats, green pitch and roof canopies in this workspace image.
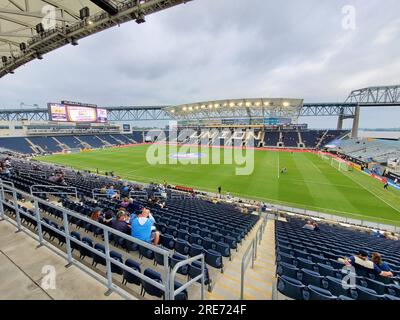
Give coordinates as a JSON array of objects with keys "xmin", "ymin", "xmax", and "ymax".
[{"xmin": 0, "ymin": 0, "xmax": 400, "ymax": 302}]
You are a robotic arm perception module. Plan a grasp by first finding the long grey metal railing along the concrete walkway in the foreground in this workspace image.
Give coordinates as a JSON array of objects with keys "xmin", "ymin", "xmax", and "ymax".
[{"xmin": 0, "ymin": 181, "xmax": 204, "ymax": 300}]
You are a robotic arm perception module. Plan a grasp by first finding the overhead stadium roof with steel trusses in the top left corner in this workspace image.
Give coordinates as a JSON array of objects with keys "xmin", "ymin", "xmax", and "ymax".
[{"xmin": 0, "ymin": 0, "xmax": 191, "ymax": 78}]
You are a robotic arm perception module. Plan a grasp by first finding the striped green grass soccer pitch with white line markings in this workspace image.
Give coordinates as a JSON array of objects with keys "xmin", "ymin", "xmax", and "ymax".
[{"xmin": 37, "ymin": 145, "xmax": 400, "ymax": 225}]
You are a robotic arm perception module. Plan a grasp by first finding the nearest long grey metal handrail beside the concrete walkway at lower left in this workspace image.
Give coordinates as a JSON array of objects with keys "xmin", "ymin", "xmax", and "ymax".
[{"xmin": 0, "ymin": 179, "xmax": 205, "ymax": 300}]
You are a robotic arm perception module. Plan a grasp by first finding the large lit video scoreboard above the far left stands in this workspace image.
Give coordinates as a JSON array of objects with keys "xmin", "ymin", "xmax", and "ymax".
[{"xmin": 48, "ymin": 101, "xmax": 108, "ymax": 123}]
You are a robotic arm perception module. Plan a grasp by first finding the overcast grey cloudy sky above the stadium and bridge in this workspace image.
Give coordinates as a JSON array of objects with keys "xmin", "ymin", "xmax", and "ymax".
[{"xmin": 0, "ymin": 0, "xmax": 400, "ymax": 127}]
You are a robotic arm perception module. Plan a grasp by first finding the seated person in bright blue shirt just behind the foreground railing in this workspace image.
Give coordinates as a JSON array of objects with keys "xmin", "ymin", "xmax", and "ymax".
[{"xmin": 132, "ymin": 209, "xmax": 160, "ymax": 245}]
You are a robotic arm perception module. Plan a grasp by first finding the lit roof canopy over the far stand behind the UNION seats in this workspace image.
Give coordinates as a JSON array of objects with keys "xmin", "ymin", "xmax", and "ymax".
[{"xmin": 164, "ymin": 98, "xmax": 303, "ymax": 119}]
